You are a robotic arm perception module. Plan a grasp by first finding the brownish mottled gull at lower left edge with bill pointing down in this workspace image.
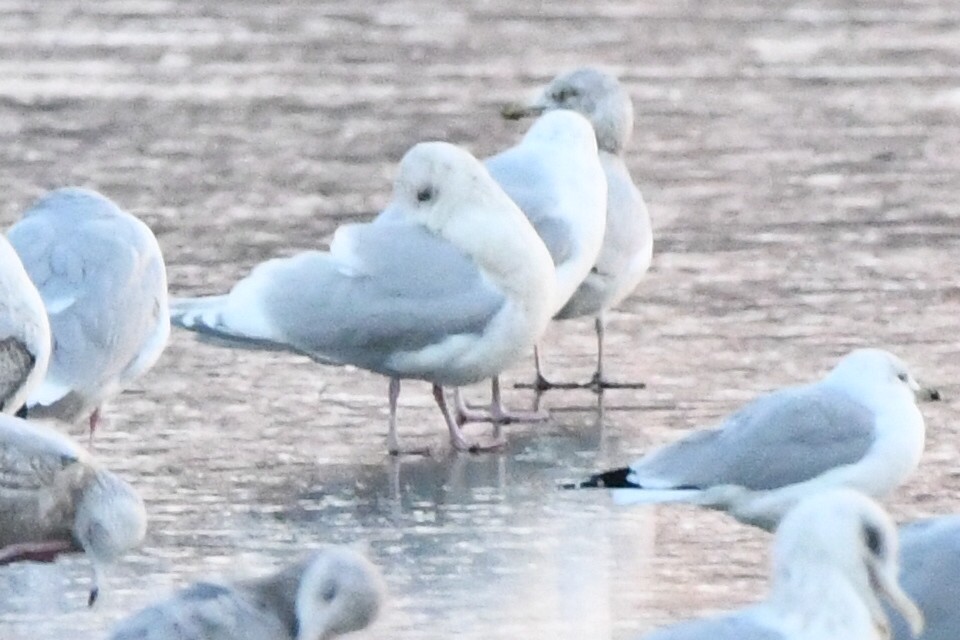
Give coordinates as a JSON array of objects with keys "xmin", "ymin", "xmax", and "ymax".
[{"xmin": 0, "ymin": 415, "xmax": 147, "ymax": 605}]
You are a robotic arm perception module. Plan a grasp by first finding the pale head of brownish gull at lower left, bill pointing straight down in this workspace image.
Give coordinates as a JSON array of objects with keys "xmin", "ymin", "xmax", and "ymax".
[{"xmin": 73, "ymin": 469, "xmax": 147, "ymax": 606}]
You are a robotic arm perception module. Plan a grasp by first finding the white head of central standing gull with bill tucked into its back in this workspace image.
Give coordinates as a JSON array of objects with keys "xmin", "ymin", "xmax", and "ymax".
[{"xmin": 381, "ymin": 142, "xmax": 516, "ymax": 232}]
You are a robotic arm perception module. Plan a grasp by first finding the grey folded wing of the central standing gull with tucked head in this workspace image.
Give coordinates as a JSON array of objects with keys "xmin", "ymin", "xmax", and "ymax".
[{"xmin": 253, "ymin": 222, "xmax": 506, "ymax": 375}]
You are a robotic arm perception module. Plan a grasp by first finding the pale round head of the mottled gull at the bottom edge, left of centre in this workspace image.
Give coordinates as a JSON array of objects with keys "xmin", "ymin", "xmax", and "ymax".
[{"xmin": 296, "ymin": 546, "xmax": 384, "ymax": 640}]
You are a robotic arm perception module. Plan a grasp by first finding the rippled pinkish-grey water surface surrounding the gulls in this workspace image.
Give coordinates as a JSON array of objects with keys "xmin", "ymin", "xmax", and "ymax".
[{"xmin": 0, "ymin": 0, "xmax": 960, "ymax": 640}]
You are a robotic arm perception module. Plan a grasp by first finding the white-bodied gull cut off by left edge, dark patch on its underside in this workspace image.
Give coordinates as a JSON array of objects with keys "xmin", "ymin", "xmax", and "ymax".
[{"xmin": 0, "ymin": 235, "xmax": 50, "ymax": 414}]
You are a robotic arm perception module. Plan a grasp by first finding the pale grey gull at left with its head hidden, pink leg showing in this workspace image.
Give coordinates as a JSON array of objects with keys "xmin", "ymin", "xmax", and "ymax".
[{"xmin": 7, "ymin": 187, "xmax": 170, "ymax": 441}]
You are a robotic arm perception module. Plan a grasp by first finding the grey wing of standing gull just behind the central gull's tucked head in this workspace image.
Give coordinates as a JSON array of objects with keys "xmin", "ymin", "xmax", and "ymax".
[{"xmin": 484, "ymin": 147, "xmax": 574, "ymax": 265}]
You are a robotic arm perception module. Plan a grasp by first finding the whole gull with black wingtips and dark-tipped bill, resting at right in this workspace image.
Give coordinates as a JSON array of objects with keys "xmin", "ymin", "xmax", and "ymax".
[{"xmin": 576, "ymin": 349, "xmax": 940, "ymax": 530}]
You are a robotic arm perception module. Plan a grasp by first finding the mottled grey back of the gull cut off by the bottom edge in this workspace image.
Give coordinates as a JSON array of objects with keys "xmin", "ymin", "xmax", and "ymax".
[{"xmin": 110, "ymin": 583, "xmax": 284, "ymax": 640}]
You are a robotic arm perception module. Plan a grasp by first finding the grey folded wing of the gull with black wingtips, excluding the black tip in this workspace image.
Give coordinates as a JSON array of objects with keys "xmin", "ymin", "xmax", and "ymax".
[{"xmin": 631, "ymin": 384, "xmax": 874, "ymax": 491}]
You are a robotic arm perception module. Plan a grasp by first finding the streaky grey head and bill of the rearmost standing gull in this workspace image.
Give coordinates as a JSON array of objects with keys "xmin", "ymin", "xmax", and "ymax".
[{"xmin": 500, "ymin": 67, "xmax": 633, "ymax": 154}]
